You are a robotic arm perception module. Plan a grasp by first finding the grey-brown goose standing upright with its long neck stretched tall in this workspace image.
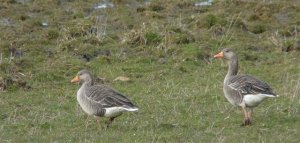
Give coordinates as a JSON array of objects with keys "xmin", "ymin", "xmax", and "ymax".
[{"xmin": 214, "ymin": 48, "xmax": 278, "ymax": 125}]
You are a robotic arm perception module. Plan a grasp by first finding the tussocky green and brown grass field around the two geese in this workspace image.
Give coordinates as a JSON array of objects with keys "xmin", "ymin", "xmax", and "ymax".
[{"xmin": 0, "ymin": 0, "xmax": 300, "ymax": 143}]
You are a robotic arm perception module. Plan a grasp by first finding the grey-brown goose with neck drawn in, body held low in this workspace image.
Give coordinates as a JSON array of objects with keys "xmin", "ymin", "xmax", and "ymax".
[{"xmin": 71, "ymin": 70, "xmax": 138, "ymax": 126}]
